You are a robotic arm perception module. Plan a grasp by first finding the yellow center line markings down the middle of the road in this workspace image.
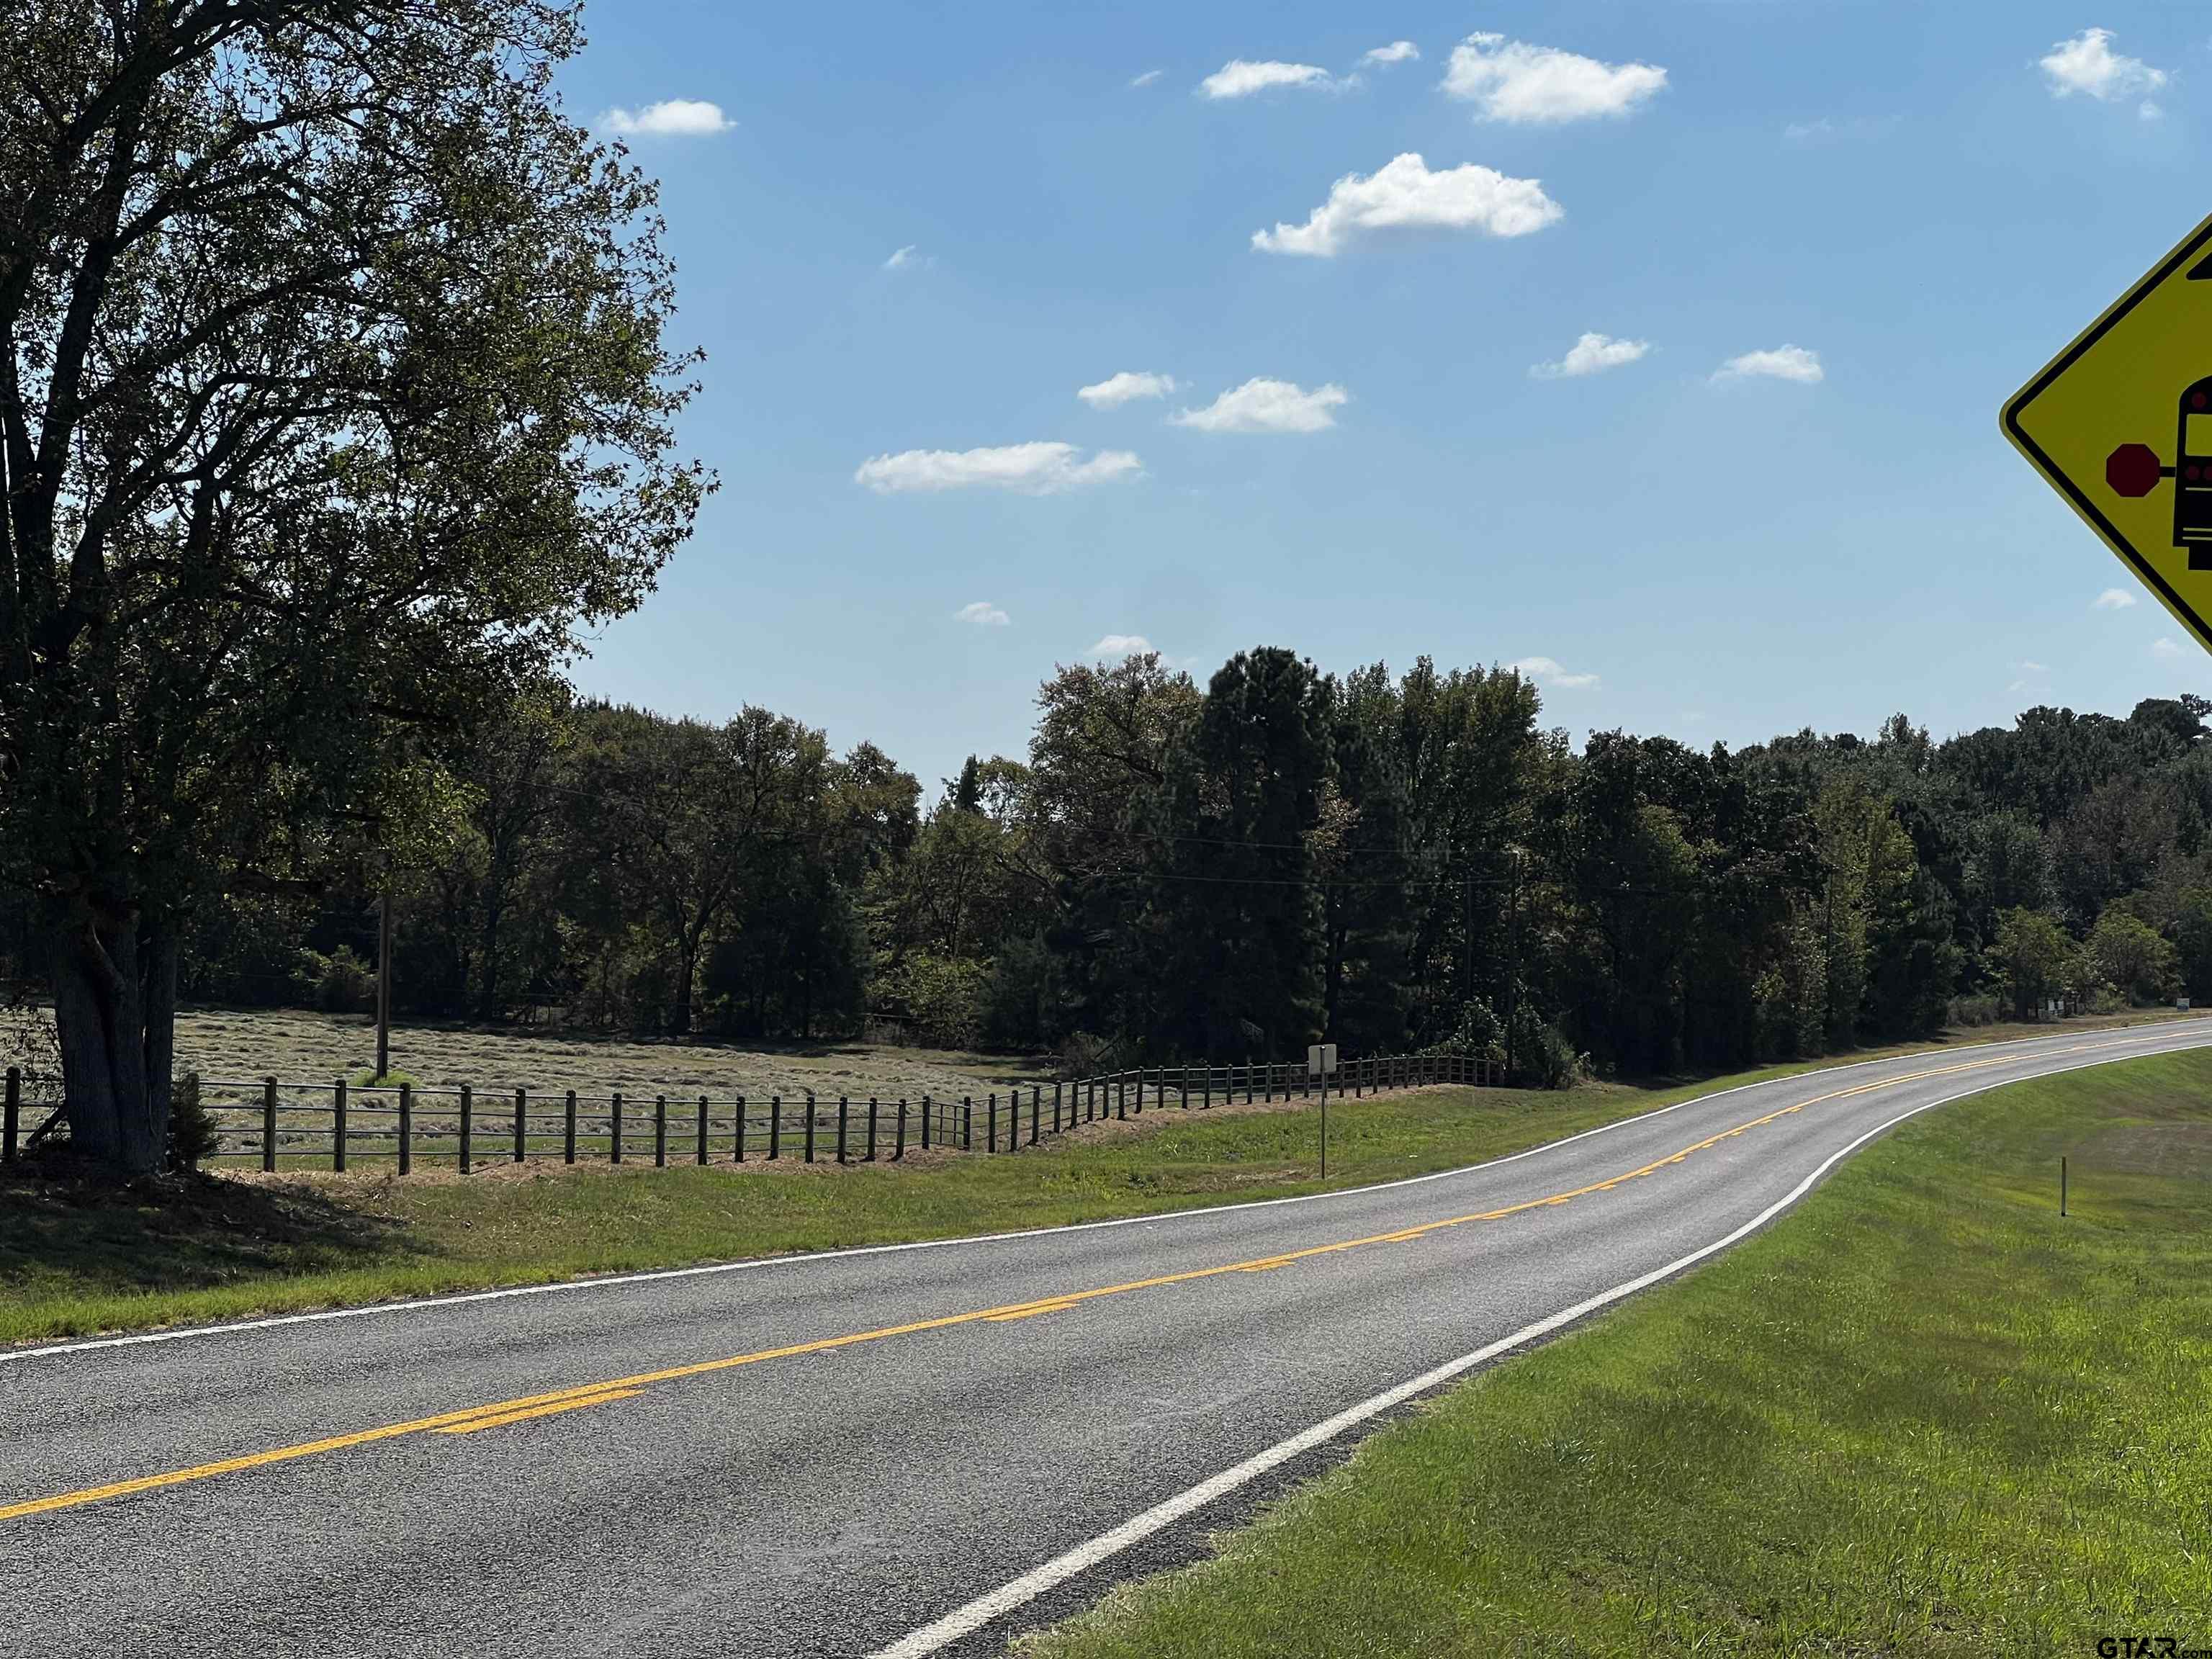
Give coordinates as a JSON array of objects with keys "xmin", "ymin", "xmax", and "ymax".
[{"xmin": 0, "ymin": 1042, "xmax": 2121, "ymax": 1522}]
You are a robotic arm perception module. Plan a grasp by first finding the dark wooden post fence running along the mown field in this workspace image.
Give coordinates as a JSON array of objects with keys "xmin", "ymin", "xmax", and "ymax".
[{"xmin": 0, "ymin": 1055, "xmax": 1498, "ymax": 1174}]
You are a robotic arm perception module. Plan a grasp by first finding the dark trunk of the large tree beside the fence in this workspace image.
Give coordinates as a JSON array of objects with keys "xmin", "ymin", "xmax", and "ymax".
[{"xmin": 53, "ymin": 907, "xmax": 177, "ymax": 1174}]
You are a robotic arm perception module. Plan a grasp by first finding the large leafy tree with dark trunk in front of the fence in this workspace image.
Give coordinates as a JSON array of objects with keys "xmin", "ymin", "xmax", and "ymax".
[{"xmin": 0, "ymin": 0, "xmax": 712, "ymax": 1170}]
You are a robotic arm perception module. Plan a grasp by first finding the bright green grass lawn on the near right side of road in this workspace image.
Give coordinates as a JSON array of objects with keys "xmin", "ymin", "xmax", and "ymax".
[{"xmin": 1022, "ymin": 1053, "xmax": 2212, "ymax": 1659}]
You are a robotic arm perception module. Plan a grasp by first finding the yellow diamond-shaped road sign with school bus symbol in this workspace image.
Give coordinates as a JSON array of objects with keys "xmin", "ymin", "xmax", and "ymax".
[{"xmin": 2004, "ymin": 219, "xmax": 2212, "ymax": 650}]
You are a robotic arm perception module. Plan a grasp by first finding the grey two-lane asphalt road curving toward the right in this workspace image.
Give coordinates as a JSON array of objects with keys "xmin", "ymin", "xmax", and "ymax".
[{"xmin": 0, "ymin": 1022, "xmax": 2212, "ymax": 1659}]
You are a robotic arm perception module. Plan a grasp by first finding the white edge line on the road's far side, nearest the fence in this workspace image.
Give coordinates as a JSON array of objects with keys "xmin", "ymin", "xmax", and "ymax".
[{"xmin": 0, "ymin": 1015, "xmax": 2212, "ymax": 1364}]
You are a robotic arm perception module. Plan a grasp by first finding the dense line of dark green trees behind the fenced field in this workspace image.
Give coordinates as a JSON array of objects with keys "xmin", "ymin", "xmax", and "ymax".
[{"xmin": 16, "ymin": 648, "xmax": 2212, "ymax": 1084}]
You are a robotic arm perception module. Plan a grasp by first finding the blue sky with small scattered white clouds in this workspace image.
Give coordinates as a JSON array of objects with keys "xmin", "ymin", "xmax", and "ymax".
[{"xmin": 564, "ymin": 0, "xmax": 2212, "ymax": 790}]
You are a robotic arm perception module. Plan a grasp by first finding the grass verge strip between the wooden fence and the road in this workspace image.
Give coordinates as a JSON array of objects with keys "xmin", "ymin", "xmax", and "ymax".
[{"xmin": 0, "ymin": 1020, "xmax": 2194, "ymax": 1343}]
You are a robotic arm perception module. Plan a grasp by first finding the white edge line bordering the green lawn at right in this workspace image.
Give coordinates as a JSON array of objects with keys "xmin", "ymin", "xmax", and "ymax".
[{"xmin": 869, "ymin": 1059, "xmax": 2141, "ymax": 1659}]
